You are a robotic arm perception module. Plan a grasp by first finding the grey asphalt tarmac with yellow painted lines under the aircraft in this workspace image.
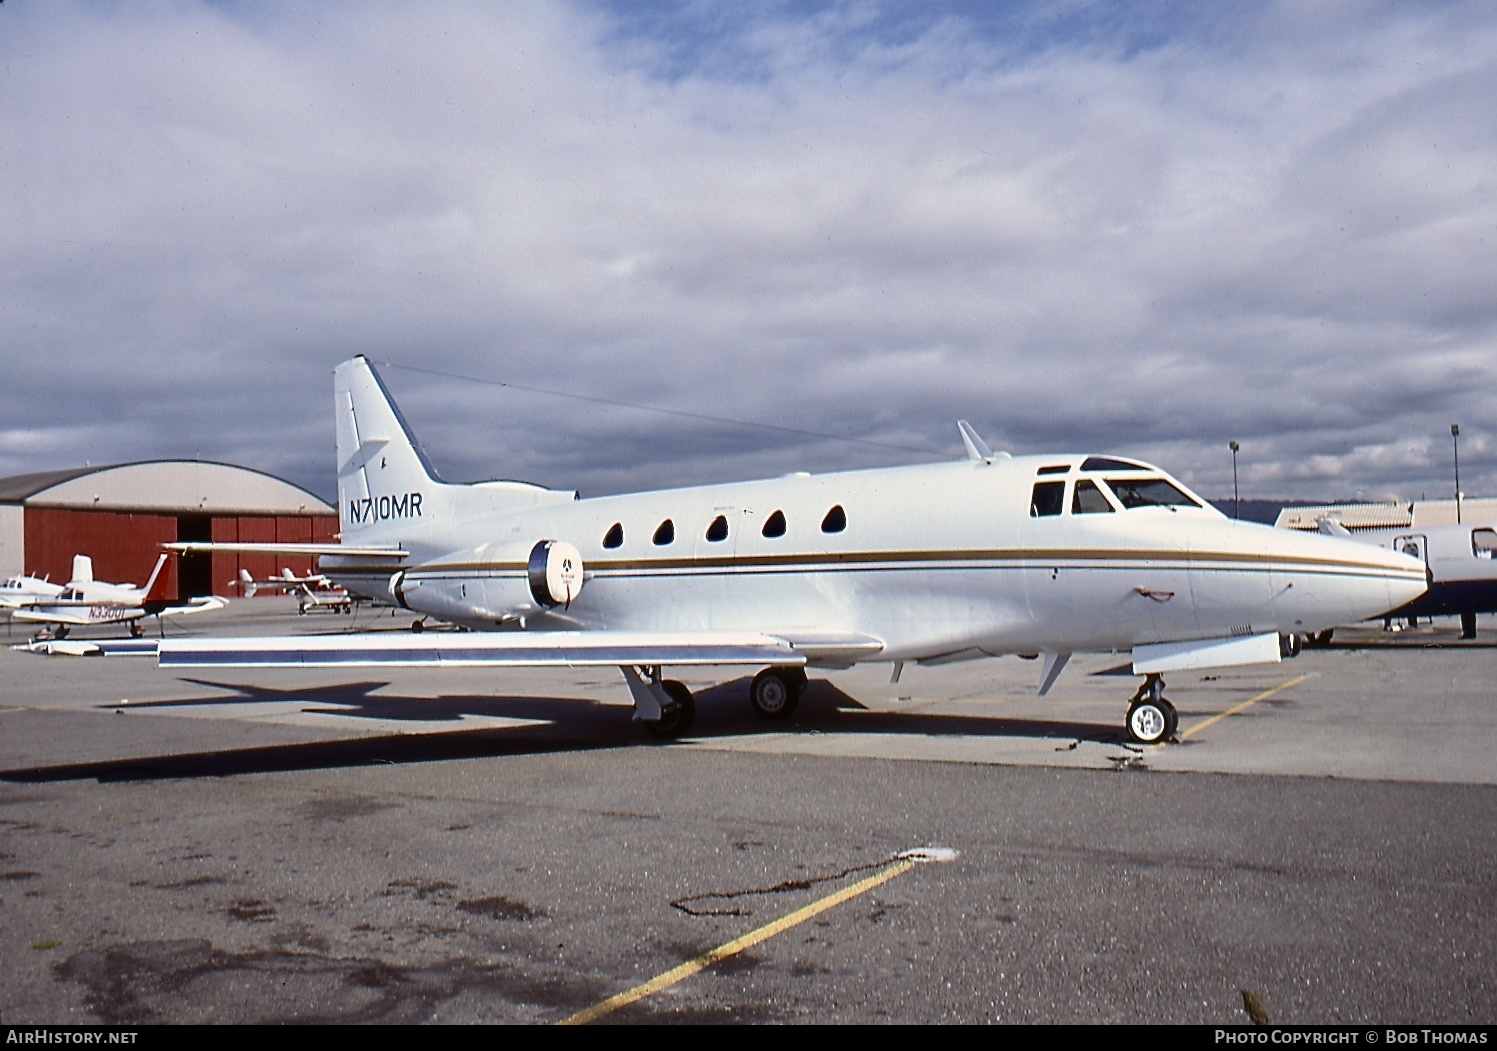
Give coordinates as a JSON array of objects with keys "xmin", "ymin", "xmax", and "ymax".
[{"xmin": 0, "ymin": 599, "xmax": 1497, "ymax": 1026}]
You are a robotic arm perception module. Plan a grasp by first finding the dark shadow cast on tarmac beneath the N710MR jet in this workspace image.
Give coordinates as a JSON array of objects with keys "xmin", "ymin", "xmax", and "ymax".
[{"xmin": 0, "ymin": 680, "xmax": 1123, "ymax": 783}]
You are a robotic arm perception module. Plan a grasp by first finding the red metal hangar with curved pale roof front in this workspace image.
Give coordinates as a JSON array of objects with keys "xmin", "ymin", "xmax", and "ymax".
[{"xmin": 0, "ymin": 460, "xmax": 338, "ymax": 600}]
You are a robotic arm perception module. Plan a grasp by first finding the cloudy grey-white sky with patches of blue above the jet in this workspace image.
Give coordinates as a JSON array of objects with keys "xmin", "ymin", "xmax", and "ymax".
[{"xmin": 0, "ymin": 0, "xmax": 1497, "ymax": 502}]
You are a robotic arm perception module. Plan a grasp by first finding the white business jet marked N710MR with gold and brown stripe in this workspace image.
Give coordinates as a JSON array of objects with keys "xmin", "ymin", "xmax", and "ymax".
[{"xmin": 159, "ymin": 356, "xmax": 1425, "ymax": 743}]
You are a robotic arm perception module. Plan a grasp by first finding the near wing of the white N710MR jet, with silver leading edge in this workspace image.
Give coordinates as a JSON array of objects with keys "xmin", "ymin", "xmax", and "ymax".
[{"xmin": 157, "ymin": 632, "xmax": 807, "ymax": 668}]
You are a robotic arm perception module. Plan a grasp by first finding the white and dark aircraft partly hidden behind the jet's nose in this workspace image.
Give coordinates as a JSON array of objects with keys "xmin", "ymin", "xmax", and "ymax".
[{"xmin": 1316, "ymin": 518, "xmax": 1497, "ymax": 641}]
